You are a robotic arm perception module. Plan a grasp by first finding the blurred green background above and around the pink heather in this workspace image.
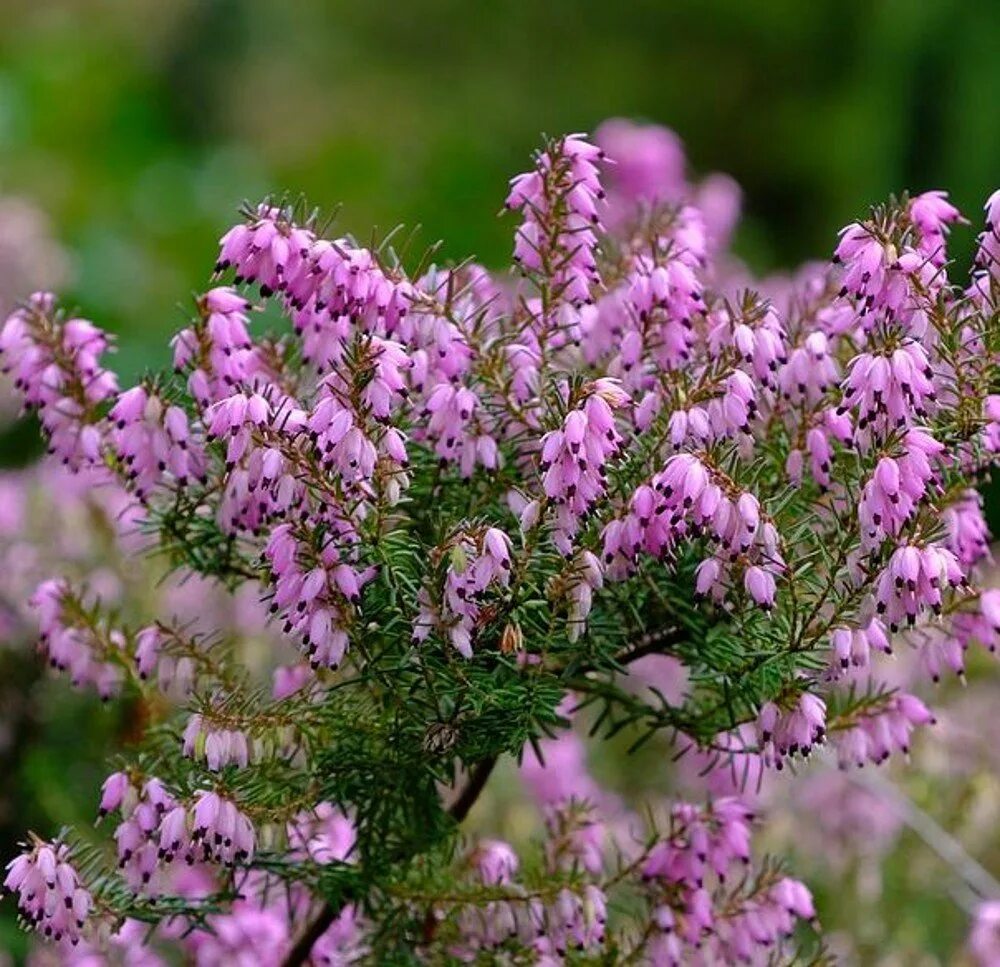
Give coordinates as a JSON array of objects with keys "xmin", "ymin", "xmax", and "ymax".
[{"xmin": 0, "ymin": 0, "xmax": 1000, "ymax": 964}]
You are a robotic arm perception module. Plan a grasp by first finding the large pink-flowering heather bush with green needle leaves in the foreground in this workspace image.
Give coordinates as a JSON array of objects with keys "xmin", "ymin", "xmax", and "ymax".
[{"xmin": 0, "ymin": 122, "xmax": 1000, "ymax": 964}]
